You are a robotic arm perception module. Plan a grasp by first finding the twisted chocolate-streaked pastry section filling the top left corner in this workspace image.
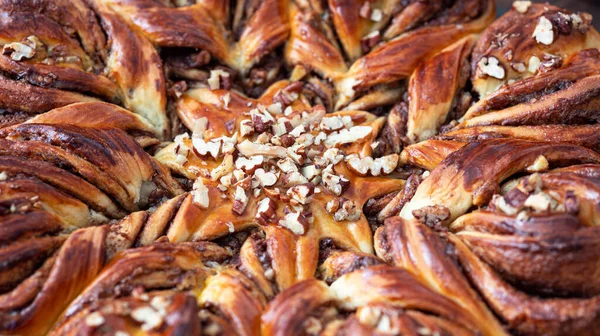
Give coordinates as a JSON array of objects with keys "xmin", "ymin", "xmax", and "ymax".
[{"xmin": 0, "ymin": 0, "xmax": 168, "ymax": 137}]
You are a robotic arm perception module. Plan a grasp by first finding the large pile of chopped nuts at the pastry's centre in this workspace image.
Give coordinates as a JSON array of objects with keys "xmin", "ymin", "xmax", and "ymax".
[{"xmin": 173, "ymin": 102, "xmax": 399, "ymax": 235}]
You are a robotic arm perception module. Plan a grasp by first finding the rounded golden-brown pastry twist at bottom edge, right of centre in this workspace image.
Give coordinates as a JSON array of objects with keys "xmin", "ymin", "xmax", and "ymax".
[{"xmin": 262, "ymin": 266, "xmax": 492, "ymax": 335}]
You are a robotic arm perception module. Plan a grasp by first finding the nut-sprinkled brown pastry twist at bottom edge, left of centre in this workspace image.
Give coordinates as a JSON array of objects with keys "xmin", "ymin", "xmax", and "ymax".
[{"xmin": 53, "ymin": 242, "xmax": 265, "ymax": 335}]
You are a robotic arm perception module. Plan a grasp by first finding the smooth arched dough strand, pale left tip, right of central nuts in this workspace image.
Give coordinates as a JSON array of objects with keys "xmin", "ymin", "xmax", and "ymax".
[{"xmin": 400, "ymin": 139, "xmax": 600, "ymax": 221}]
